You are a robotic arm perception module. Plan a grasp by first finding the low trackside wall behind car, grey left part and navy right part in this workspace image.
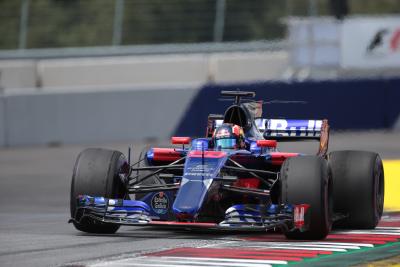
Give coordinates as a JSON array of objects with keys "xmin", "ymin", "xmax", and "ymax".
[{"xmin": 0, "ymin": 79, "xmax": 400, "ymax": 146}]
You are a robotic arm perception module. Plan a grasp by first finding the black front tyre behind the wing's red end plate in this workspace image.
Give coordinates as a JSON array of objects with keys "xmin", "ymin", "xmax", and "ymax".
[{"xmin": 281, "ymin": 156, "xmax": 332, "ymax": 240}]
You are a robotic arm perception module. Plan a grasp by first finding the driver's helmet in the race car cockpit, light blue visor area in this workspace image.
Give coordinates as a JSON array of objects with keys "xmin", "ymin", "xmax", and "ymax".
[{"xmin": 213, "ymin": 123, "xmax": 245, "ymax": 149}]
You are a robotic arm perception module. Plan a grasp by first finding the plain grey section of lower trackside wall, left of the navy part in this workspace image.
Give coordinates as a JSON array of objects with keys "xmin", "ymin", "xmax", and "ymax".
[{"xmin": 0, "ymin": 88, "xmax": 198, "ymax": 146}]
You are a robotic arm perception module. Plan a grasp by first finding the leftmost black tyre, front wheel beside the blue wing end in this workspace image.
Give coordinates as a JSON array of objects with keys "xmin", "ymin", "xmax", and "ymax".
[{"xmin": 70, "ymin": 148, "xmax": 126, "ymax": 234}]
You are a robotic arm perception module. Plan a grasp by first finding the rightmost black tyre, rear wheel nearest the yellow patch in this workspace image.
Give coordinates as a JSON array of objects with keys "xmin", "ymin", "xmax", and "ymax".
[{"xmin": 329, "ymin": 151, "xmax": 385, "ymax": 229}]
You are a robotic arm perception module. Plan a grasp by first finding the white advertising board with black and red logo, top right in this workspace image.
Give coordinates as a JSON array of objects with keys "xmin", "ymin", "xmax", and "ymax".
[{"xmin": 341, "ymin": 16, "xmax": 400, "ymax": 69}]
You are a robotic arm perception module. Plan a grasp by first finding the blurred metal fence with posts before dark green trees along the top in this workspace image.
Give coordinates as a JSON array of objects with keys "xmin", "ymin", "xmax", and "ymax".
[{"xmin": 0, "ymin": 0, "xmax": 400, "ymax": 49}]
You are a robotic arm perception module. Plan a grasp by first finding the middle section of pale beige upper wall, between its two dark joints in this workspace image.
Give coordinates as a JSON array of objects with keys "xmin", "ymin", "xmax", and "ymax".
[{"xmin": 38, "ymin": 55, "xmax": 208, "ymax": 88}]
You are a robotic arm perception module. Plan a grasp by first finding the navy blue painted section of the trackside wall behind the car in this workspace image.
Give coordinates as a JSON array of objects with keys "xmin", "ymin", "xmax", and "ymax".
[{"xmin": 176, "ymin": 79, "xmax": 400, "ymax": 136}]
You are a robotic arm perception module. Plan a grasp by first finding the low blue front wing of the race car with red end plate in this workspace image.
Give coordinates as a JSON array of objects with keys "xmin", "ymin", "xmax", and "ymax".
[{"xmin": 69, "ymin": 195, "xmax": 310, "ymax": 232}]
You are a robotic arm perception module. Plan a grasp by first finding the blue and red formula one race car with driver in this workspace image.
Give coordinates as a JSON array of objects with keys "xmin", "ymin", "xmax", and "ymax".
[{"xmin": 70, "ymin": 91, "xmax": 384, "ymax": 239}]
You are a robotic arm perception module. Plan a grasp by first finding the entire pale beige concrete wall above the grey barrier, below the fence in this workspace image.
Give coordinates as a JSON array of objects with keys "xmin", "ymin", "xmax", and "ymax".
[{"xmin": 0, "ymin": 51, "xmax": 288, "ymax": 90}]
